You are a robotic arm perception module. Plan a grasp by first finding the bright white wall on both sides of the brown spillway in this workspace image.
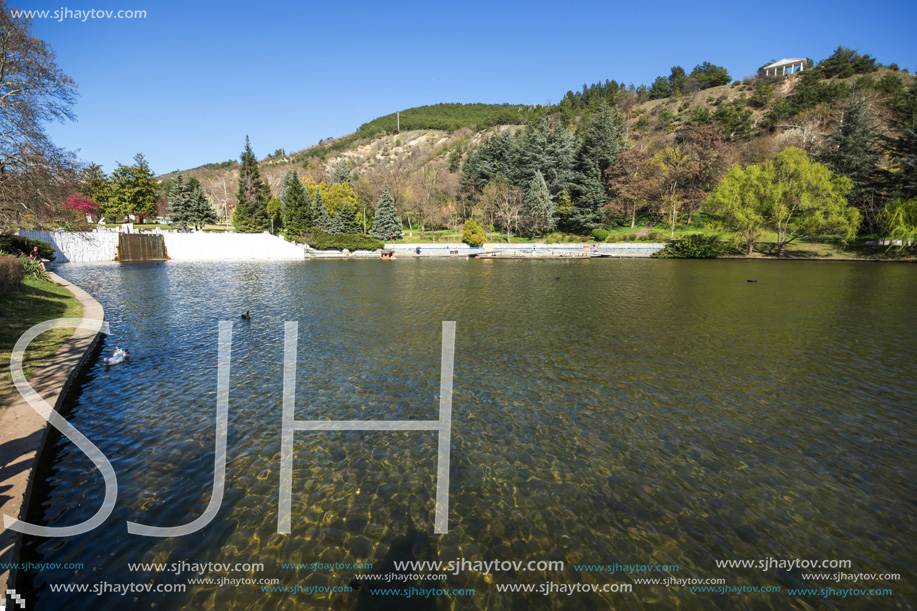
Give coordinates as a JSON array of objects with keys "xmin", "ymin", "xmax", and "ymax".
[{"xmin": 19, "ymin": 230, "xmax": 305, "ymax": 263}]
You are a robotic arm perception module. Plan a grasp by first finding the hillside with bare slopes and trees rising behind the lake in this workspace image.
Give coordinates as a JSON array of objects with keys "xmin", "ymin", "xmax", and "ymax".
[{"xmin": 161, "ymin": 47, "xmax": 917, "ymax": 244}]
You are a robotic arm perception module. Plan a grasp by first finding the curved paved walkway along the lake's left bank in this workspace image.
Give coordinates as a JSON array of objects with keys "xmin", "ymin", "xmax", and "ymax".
[{"xmin": 0, "ymin": 273, "xmax": 105, "ymax": 603}]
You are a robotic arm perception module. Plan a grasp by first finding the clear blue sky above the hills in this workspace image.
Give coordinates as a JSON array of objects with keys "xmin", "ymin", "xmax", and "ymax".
[{"xmin": 19, "ymin": 0, "xmax": 917, "ymax": 173}]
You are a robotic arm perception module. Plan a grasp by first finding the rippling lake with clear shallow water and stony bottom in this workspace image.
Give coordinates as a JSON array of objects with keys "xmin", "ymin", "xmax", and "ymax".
[{"xmin": 19, "ymin": 259, "xmax": 917, "ymax": 611}]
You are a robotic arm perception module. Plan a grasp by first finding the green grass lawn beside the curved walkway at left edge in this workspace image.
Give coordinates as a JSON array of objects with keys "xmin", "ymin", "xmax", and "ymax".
[{"xmin": 0, "ymin": 278, "xmax": 83, "ymax": 403}]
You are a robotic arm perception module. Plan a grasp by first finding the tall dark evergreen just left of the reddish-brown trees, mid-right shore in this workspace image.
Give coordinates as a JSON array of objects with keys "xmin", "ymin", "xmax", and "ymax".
[{"xmin": 568, "ymin": 105, "xmax": 624, "ymax": 233}]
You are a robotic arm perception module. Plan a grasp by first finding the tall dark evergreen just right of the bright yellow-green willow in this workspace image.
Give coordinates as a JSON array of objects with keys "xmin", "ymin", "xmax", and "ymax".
[{"xmin": 814, "ymin": 97, "xmax": 882, "ymax": 233}]
